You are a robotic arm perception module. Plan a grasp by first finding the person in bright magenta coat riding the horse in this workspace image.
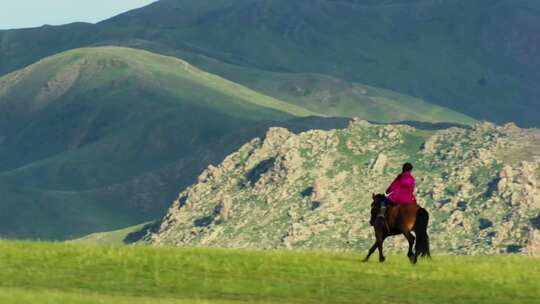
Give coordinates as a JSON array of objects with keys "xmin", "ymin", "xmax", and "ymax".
[{"xmin": 379, "ymin": 163, "xmax": 416, "ymax": 217}]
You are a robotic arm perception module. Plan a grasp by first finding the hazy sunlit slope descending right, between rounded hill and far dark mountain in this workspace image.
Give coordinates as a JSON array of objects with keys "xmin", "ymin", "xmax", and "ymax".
[{"xmin": 161, "ymin": 45, "xmax": 475, "ymax": 125}]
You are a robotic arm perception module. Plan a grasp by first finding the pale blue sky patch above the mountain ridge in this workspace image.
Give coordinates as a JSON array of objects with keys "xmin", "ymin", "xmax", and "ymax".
[{"xmin": 0, "ymin": 0, "xmax": 155, "ymax": 29}]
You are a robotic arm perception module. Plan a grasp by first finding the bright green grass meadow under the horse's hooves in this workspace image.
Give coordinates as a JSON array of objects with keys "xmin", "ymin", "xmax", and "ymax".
[{"xmin": 0, "ymin": 242, "xmax": 540, "ymax": 304}]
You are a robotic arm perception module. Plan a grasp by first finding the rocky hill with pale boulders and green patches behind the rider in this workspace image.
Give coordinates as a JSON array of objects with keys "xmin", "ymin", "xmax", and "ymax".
[{"xmin": 145, "ymin": 120, "xmax": 540, "ymax": 255}]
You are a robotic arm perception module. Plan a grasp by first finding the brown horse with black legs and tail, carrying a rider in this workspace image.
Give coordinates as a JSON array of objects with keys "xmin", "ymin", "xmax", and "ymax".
[{"xmin": 364, "ymin": 194, "xmax": 431, "ymax": 264}]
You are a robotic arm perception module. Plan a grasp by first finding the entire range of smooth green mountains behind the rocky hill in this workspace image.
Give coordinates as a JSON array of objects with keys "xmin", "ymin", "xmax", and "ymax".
[{"xmin": 0, "ymin": 0, "xmax": 540, "ymax": 239}]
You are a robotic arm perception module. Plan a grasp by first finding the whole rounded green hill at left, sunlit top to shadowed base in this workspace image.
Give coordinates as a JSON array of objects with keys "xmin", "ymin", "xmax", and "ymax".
[{"xmin": 0, "ymin": 48, "xmax": 311, "ymax": 238}]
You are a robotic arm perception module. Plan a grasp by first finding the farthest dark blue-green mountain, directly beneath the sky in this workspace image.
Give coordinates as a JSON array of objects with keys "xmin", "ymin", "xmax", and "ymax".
[{"xmin": 0, "ymin": 0, "xmax": 540, "ymax": 126}]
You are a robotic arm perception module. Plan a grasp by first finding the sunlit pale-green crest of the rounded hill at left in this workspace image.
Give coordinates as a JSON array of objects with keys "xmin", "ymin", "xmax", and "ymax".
[{"xmin": 0, "ymin": 46, "xmax": 314, "ymax": 118}]
